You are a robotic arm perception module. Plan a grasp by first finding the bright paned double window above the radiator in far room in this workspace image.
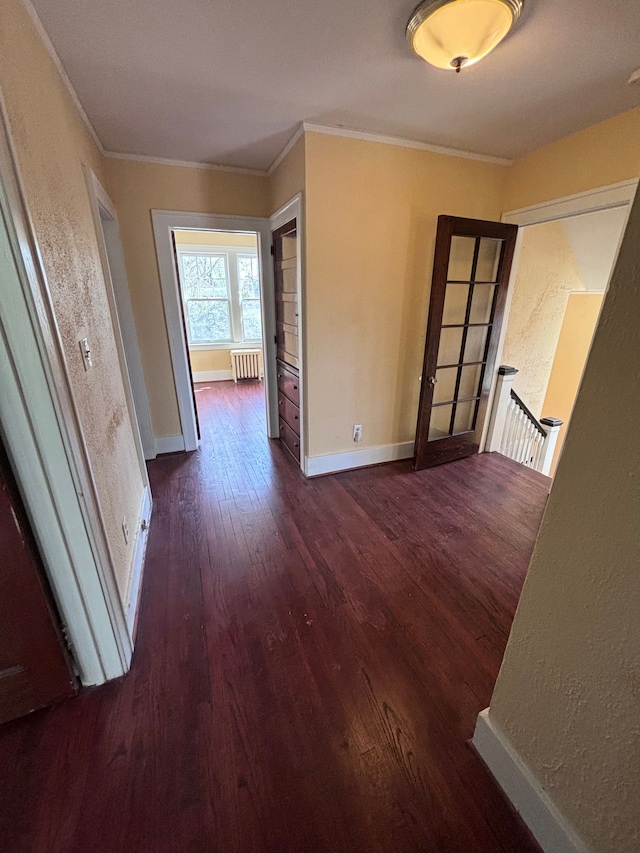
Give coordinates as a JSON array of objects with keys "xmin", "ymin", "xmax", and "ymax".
[{"xmin": 178, "ymin": 241, "xmax": 262, "ymax": 348}]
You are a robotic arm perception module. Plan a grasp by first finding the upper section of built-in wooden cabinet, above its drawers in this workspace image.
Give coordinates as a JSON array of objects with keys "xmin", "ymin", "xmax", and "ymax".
[{"xmin": 272, "ymin": 219, "xmax": 300, "ymax": 370}]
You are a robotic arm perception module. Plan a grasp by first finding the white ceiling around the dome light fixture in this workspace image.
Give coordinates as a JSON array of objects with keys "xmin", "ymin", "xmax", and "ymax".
[{"xmin": 28, "ymin": 0, "xmax": 640, "ymax": 169}]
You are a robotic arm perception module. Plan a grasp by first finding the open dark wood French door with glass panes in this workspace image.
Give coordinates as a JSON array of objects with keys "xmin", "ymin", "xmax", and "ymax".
[{"xmin": 414, "ymin": 216, "xmax": 518, "ymax": 470}]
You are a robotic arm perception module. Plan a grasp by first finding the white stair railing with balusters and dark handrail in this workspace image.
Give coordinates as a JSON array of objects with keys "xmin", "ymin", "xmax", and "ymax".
[{"xmin": 486, "ymin": 365, "xmax": 563, "ymax": 476}]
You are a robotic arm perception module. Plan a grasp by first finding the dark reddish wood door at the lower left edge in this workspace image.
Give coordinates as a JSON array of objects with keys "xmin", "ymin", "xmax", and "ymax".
[{"xmin": 0, "ymin": 444, "xmax": 76, "ymax": 722}]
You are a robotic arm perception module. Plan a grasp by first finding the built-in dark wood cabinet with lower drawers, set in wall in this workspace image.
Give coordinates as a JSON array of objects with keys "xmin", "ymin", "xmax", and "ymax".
[{"xmin": 272, "ymin": 219, "xmax": 300, "ymax": 462}]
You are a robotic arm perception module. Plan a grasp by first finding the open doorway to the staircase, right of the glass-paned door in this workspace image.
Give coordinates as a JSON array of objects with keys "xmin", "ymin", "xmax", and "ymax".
[{"xmin": 486, "ymin": 181, "xmax": 637, "ymax": 477}]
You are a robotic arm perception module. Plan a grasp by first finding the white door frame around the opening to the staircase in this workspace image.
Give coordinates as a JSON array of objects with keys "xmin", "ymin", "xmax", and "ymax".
[{"xmin": 480, "ymin": 178, "xmax": 640, "ymax": 453}]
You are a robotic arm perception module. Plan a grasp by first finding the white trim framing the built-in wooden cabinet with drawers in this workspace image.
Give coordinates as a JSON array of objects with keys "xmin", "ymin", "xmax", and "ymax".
[{"xmin": 269, "ymin": 193, "xmax": 309, "ymax": 476}]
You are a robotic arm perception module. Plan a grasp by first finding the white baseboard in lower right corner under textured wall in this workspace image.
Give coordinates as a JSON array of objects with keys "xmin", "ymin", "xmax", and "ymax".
[{"xmin": 473, "ymin": 708, "xmax": 590, "ymax": 853}]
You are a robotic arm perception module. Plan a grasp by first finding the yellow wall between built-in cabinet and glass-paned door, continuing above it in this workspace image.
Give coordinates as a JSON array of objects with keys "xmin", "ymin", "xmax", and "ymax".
[{"xmin": 305, "ymin": 133, "xmax": 507, "ymax": 456}]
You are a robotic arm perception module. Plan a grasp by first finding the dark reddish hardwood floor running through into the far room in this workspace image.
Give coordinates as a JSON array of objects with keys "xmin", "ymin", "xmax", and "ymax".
[{"xmin": 0, "ymin": 383, "xmax": 547, "ymax": 853}]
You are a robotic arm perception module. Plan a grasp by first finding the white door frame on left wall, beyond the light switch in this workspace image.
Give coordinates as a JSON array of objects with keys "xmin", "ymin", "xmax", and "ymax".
[{"xmin": 85, "ymin": 166, "xmax": 156, "ymax": 460}]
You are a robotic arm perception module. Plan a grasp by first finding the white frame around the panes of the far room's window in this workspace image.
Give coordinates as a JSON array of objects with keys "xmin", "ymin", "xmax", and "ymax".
[{"xmin": 176, "ymin": 243, "xmax": 262, "ymax": 350}]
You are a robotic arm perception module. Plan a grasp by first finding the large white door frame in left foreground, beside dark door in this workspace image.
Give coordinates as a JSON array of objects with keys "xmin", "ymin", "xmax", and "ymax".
[{"xmin": 0, "ymin": 94, "xmax": 133, "ymax": 685}]
